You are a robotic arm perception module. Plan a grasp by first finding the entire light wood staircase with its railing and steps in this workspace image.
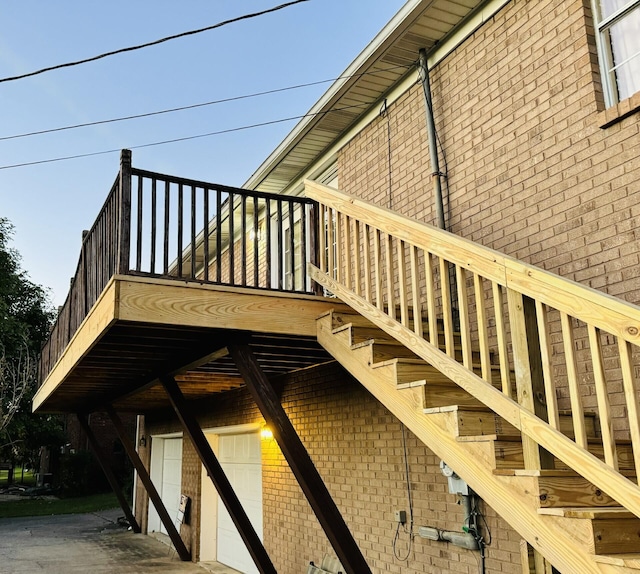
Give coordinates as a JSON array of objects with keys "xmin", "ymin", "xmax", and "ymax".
[{"xmin": 306, "ymin": 182, "xmax": 640, "ymax": 572}]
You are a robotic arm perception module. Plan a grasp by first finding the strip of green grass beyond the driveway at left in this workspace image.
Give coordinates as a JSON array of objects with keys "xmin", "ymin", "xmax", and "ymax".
[{"xmin": 0, "ymin": 492, "xmax": 118, "ymax": 518}]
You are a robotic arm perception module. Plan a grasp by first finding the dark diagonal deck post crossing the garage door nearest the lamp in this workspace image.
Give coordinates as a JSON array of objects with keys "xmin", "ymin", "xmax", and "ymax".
[{"xmin": 160, "ymin": 376, "xmax": 277, "ymax": 574}]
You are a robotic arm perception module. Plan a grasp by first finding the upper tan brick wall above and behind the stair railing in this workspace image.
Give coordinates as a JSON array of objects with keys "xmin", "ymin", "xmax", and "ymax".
[{"xmin": 338, "ymin": 0, "xmax": 640, "ymax": 438}]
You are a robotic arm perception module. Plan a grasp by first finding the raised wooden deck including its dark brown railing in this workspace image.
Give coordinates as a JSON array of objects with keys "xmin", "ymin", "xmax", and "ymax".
[{"xmin": 33, "ymin": 150, "xmax": 332, "ymax": 413}]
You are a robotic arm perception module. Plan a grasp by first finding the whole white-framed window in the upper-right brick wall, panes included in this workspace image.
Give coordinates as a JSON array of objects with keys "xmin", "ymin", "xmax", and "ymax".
[{"xmin": 593, "ymin": 0, "xmax": 640, "ymax": 106}]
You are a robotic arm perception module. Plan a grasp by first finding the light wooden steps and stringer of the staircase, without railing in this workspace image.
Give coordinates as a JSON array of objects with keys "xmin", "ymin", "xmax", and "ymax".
[{"xmin": 318, "ymin": 311, "xmax": 640, "ymax": 574}]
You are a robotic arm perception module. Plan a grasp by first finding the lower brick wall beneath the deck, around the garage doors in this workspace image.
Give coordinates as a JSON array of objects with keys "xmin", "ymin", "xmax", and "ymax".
[{"xmin": 146, "ymin": 364, "xmax": 521, "ymax": 574}]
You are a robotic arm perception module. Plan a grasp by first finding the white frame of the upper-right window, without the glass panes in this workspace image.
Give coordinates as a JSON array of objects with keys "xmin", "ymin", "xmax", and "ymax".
[{"xmin": 592, "ymin": 0, "xmax": 640, "ymax": 107}]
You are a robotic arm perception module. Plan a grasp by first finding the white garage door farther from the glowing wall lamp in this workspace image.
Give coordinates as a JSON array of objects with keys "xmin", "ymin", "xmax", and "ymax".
[{"xmin": 149, "ymin": 437, "xmax": 182, "ymax": 534}]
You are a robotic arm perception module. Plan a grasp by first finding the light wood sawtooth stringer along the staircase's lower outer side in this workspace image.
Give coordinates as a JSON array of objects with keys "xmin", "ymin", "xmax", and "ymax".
[{"xmin": 318, "ymin": 315, "xmax": 616, "ymax": 574}]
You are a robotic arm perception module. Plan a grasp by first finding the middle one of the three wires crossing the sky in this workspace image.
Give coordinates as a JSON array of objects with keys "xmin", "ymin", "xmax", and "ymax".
[{"xmin": 0, "ymin": 63, "xmax": 413, "ymax": 141}]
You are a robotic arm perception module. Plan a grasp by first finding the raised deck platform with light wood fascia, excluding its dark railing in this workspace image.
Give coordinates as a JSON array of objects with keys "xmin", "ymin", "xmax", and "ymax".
[{"xmin": 33, "ymin": 275, "xmax": 343, "ymax": 412}]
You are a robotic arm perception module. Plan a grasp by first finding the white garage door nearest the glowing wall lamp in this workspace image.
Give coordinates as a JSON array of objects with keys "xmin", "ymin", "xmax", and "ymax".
[{"xmin": 218, "ymin": 433, "xmax": 262, "ymax": 574}]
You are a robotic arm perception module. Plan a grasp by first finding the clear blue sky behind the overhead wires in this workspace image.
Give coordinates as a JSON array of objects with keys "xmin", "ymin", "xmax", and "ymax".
[{"xmin": 0, "ymin": 0, "xmax": 404, "ymax": 305}]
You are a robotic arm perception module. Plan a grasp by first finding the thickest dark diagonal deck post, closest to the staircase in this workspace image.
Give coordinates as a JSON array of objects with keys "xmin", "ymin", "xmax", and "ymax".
[{"xmin": 228, "ymin": 344, "xmax": 371, "ymax": 574}]
